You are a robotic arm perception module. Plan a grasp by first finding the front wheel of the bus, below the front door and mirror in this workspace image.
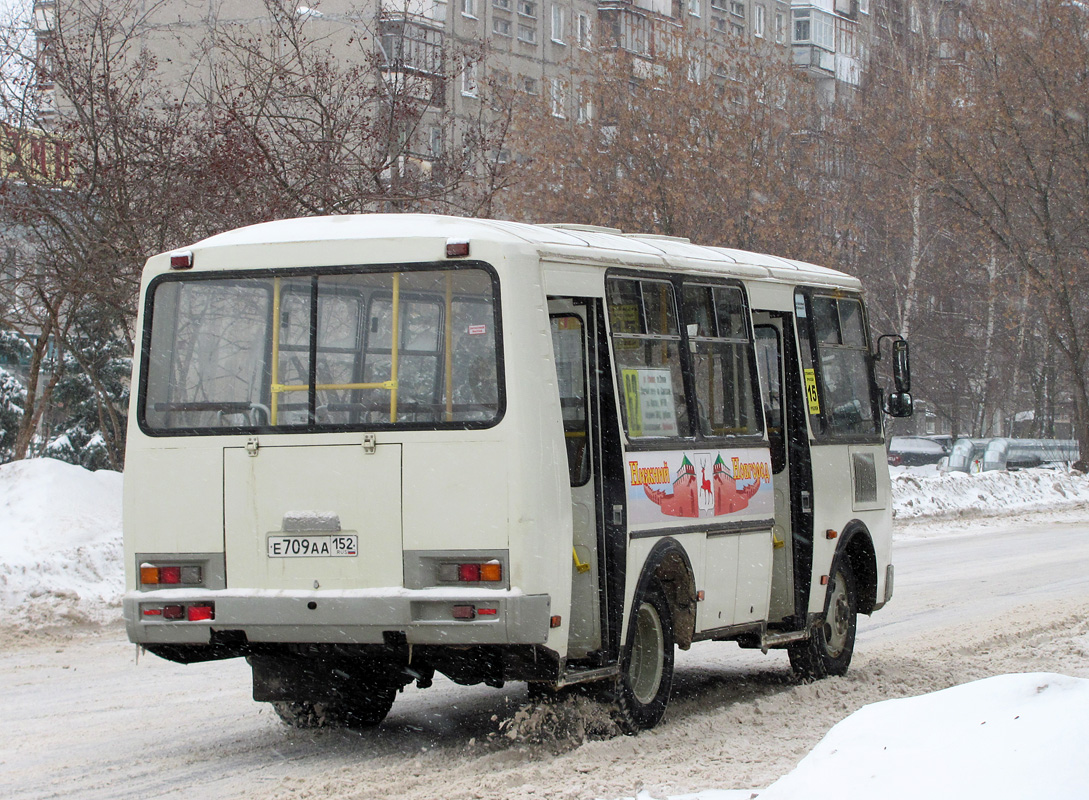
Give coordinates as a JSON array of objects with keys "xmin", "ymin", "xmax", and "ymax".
[{"xmin": 787, "ymin": 558, "xmax": 858, "ymax": 680}]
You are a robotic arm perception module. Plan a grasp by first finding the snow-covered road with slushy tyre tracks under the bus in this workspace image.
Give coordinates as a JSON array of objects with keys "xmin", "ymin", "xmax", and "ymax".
[{"xmin": 0, "ymin": 514, "xmax": 1089, "ymax": 800}]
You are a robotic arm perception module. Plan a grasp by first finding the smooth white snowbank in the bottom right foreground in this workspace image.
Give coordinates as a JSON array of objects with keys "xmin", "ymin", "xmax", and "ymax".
[{"xmin": 622, "ymin": 673, "xmax": 1089, "ymax": 800}]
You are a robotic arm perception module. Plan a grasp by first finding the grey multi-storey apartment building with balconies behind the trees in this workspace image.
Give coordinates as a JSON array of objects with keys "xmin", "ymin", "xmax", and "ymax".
[{"xmin": 25, "ymin": 0, "xmax": 870, "ymax": 159}]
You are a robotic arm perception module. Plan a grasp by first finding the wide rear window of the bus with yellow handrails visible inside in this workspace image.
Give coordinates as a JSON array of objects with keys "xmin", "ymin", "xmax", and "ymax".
[{"xmin": 140, "ymin": 266, "xmax": 502, "ymax": 433}]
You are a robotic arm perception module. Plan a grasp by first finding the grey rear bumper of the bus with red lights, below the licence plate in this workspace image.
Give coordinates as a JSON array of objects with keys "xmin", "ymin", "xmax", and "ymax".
[{"xmin": 122, "ymin": 588, "xmax": 551, "ymax": 645}]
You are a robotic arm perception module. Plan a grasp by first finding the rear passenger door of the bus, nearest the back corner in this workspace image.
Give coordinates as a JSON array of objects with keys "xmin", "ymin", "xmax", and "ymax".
[{"xmin": 549, "ymin": 297, "xmax": 603, "ymax": 660}]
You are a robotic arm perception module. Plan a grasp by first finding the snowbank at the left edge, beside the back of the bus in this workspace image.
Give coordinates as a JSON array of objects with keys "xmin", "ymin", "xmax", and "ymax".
[{"xmin": 0, "ymin": 458, "xmax": 124, "ymax": 627}]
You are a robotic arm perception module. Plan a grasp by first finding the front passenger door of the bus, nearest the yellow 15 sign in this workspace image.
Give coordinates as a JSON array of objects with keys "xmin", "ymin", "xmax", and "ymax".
[{"xmin": 752, "ymin": 311, "xmax": 812, "ymax": 627}]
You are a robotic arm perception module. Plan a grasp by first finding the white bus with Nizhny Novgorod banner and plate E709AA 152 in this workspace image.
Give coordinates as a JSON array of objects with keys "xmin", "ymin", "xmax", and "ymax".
[{"xmin": 124, "ymin": 214, "xmax": 911, "ymax": 733}]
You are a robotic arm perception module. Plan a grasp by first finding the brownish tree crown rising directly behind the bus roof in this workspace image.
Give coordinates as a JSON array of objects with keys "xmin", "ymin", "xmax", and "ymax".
[{"xmin": 507, "ymin": 38, "xmax": 816, "ymax": 257}]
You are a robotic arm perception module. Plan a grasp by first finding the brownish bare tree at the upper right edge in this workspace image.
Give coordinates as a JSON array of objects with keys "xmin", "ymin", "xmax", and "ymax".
[{"xmin": 934, "ymin": 0, "xmax": 1089, "ymax": 452}]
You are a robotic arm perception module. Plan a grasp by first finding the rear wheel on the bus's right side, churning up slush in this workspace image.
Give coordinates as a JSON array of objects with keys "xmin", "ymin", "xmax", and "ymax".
[{"xmin": 613, "ymin": 578, "xmax": 673, "ymax": 735}]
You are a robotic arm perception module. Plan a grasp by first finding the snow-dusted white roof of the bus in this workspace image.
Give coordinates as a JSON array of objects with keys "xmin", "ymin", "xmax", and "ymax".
[{"xmin": 182, "ymin": 213, "xmax": 860, "ymax": 290}]
